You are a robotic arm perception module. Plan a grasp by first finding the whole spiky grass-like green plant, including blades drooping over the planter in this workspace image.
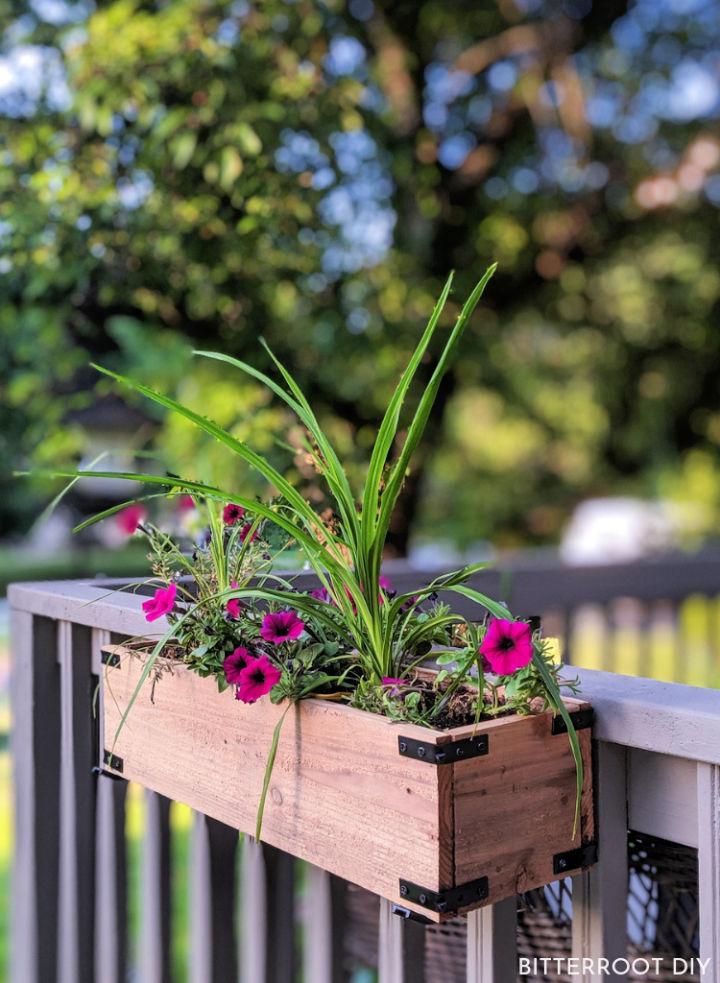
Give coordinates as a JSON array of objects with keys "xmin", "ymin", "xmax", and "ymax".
[{"xmin": 21, "ymin": 264, "xmax": 583, "ymax": 826}]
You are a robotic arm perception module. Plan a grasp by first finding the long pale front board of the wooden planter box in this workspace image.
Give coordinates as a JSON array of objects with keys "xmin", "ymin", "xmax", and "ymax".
[{"xmin": 104, "ymin": 656, "xmax": 449, "ymax": 916}]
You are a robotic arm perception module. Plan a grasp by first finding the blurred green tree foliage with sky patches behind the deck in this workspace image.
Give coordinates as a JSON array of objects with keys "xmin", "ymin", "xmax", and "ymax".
[{"xmin": 0, "ymin": 0, "xmax": 720, "ymax": 550}]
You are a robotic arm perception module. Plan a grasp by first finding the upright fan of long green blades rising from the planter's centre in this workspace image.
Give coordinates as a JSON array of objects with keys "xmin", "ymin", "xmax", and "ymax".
[{"xmin": 56, "ymin": 264, "xmax": 500, "ymax": 682}]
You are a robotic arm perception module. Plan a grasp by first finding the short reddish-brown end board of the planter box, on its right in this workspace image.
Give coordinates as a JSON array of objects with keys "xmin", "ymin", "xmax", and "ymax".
[{"xmin": 454, "ymin": 716, "xmax": 595, "ymax": 902}]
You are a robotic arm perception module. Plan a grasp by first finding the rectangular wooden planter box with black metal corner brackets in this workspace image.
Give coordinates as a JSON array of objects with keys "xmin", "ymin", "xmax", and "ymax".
[{"xmin": 102, "ymin": 646, "xmax": 596, "ymax": 922}]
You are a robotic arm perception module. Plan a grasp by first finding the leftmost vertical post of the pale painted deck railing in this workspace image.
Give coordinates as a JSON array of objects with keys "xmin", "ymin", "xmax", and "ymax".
[{"xmin": 10, "ymin": 609, "xmax": 60, "ymax": 983}]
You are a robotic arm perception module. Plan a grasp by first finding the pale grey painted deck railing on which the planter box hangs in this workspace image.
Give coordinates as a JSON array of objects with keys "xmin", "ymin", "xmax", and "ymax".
[{"xmin": 10, "ymin": 582, "xmax": 720, "ymax": 983}]
